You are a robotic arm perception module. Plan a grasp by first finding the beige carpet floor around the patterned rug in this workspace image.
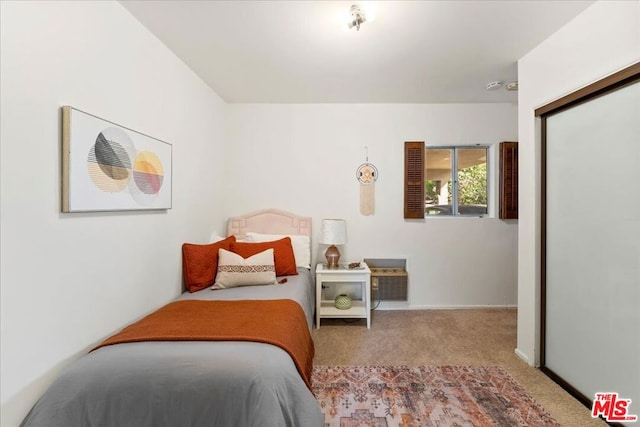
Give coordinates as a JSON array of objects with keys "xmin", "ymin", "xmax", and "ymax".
[{"xmin": 312, "ymin": 309, "xmax": 606, "ymax": 427}]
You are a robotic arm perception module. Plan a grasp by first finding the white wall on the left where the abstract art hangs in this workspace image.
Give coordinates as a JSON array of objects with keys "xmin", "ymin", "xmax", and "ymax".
[{"xmin": 0, "ymin": 1, "xmax": 226, "ymax": 426}]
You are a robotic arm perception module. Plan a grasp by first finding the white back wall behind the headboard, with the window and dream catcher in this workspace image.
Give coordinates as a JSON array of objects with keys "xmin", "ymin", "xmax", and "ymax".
[{"xmin": 228, "ymin": 104, "xmax": 518, "ymax": 308}]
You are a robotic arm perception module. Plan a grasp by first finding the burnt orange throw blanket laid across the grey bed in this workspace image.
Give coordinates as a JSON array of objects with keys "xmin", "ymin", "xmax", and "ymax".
[{"xmin": 91, "ymin": 299, "xmax": 315, "ymax": 389}]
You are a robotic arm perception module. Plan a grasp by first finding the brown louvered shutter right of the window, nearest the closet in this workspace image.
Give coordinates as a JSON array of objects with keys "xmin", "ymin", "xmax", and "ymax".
[{"xmin": 499, "ymin": 142, "xmax": 518, "ymax": 219}]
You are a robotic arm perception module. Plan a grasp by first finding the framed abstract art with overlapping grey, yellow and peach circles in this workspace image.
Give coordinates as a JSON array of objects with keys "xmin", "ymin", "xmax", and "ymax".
[{"xmin": 62, "ymin": 105, "xmax": 172, "ymax": 212}]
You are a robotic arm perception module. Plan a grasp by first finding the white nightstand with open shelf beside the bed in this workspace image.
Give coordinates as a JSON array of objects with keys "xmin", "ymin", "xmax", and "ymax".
[{"xmin": 316, "ymin": 262, "xmax": 371, "ymax": 329}]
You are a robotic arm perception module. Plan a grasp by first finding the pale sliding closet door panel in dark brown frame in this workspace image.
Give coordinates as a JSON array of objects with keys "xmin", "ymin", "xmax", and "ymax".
[{"xmin": 542, "ymin": 75, "xmax": 640, "ymax": 420}]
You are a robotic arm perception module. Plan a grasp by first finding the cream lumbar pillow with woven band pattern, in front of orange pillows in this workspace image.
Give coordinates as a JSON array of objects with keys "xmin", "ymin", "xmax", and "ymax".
[{"xmin": 211, "ymin": 249, "xmax": 276, "ymax": 289}]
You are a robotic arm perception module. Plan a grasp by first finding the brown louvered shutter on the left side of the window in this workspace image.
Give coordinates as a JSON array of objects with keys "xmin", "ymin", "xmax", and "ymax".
[{"xmin": 404, "ymin": 141, "xmax": 425, "ymax": 218}]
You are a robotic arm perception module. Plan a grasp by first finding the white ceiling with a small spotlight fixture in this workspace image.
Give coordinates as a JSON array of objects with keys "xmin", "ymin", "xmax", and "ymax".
[{"xmin": 121, "ymin": 0, "xmax": 593, "ymax": 103}]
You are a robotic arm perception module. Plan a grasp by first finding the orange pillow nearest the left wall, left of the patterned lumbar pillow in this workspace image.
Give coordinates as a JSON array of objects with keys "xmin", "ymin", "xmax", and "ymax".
[{"xmin": 182, "ymin": 236, "xmax": 236, "ymax": 292}]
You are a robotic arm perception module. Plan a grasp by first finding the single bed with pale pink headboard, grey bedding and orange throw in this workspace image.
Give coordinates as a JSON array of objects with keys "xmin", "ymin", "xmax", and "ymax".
[{"xmin": 22, "ymin": 209, "xmax": 323, "ymax": 427}]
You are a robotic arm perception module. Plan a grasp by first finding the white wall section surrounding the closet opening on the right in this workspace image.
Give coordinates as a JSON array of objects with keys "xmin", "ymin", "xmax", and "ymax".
[{"xmin": 516, "ymin": 0, "xmax": 640, "ymax": 365}]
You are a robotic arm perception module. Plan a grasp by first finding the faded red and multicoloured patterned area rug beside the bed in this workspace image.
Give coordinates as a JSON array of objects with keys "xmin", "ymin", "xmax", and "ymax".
[{"xmin": 313, "ymin": 366, "xmax": 559, "ymax": 427}]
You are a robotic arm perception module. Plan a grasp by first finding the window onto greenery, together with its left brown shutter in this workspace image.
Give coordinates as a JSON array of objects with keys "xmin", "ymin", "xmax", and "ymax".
[{"xmin": 405, "ymin": 142, "xmax": 489, "ymax": 218}]
